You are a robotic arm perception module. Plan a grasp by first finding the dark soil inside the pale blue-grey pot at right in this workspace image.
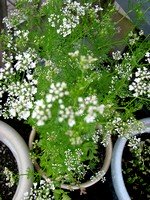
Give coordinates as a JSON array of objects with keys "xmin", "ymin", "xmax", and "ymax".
[{"xmin": 123, "ymin": 133, "xmax": 150, "ymax": 200}]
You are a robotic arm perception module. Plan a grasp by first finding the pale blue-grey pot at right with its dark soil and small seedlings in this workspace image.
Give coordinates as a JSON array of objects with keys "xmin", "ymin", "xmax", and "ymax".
[{"xmin": 111, "ymin": 118, "xmax": 150, "ymax": 200}]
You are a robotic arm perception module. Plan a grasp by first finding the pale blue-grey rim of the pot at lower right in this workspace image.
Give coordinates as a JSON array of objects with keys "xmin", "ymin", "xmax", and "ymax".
[{"xmin": 111, "ymin": 118, "xmax": 150, "ymax": 200}]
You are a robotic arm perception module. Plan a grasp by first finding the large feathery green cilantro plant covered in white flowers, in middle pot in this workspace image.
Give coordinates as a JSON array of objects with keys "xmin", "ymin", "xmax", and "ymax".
[{"xmin": 0, "ymin": 0, "xmax": 150, "ymax": 199}]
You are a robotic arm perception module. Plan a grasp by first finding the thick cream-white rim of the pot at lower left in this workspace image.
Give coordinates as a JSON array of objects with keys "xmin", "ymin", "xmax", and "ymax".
[{"xmin": 0, "ymin": 121, "xmax": 33, "ymax": 200}]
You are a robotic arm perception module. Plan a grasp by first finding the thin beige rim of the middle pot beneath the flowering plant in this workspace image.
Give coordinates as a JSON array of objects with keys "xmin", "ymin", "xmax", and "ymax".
[{"xmin": 29, "ymin": 128, "xmax": 112, "ymax": 192}]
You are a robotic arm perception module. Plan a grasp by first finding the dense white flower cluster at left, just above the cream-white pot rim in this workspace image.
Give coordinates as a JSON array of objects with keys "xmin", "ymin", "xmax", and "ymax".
[{"xmin": 2, "ymin": 79, "xmax": 37, "ymax": 120}]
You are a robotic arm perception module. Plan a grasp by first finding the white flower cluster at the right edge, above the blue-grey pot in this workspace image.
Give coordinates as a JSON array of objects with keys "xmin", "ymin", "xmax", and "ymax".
[{"xmin": 129, "ymin": 67, "xmax": 150, "ymax": 97}]
